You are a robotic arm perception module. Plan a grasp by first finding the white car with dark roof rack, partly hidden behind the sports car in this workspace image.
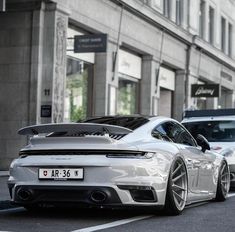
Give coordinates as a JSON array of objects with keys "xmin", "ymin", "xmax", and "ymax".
[{"xmin": 182, "ymin": 109, "xmax": 235, "ymax": 188}]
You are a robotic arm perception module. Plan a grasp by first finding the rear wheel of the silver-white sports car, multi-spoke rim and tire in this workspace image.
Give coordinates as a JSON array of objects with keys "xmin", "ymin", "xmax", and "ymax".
[{"xmin": 164, "ymin": 157, "xmax": 188, "ymax": 215}]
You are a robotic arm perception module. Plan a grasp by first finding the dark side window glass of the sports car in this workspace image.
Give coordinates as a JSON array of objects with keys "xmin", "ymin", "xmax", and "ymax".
[{"xmin": 153, "ymin": 122, "xmax": 196, "ymax": 146}]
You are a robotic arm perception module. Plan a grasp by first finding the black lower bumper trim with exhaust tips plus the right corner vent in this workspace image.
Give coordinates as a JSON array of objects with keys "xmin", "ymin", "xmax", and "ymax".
[{"xmin": 8, "ymin": 183, "xmax": 159, "ymax": 207}]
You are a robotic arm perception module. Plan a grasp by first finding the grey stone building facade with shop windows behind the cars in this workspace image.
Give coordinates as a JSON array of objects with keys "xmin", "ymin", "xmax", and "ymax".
[{"xmin": 0, "ymin": 0, "xmax": 235, "ymax": 170}]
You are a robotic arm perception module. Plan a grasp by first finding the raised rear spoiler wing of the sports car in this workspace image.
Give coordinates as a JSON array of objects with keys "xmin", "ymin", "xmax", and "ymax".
[{"xmin": 18, "ymin": 123, "xmax": 132, "ymax": 135}]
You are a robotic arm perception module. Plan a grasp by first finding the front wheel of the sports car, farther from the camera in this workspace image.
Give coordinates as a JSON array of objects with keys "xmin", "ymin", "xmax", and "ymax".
[{"xmin": 215, "ymin": 161, "xmax": 230, "ymax": 201}]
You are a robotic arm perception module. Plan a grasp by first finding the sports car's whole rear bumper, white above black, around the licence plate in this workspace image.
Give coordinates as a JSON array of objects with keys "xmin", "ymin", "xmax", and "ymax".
[{"xmin": 8, "ymin": 155, "xmax": 168, "ymax": 206}]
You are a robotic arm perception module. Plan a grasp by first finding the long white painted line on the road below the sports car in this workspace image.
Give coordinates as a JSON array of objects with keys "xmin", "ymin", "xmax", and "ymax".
[{"xmin": 72, "ymin": 215, "xmax": 154, "ymax": 232}]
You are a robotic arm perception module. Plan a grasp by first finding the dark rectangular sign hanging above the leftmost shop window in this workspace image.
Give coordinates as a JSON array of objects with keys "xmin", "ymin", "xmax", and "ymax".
[{"xmin": 74, "ymin": 34, "xmax": 107, "ymax": 53}]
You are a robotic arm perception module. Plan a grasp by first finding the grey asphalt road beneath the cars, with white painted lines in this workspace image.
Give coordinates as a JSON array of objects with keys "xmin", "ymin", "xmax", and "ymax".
[{"xmin": 0, "ymin": 193, "xmax": 235, "ymax": 232}]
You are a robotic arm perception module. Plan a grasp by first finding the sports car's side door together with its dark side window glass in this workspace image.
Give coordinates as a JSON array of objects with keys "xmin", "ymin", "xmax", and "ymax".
[{"xmin": 155, "ymin": 121, "xmax": 213, "ymax": 200}]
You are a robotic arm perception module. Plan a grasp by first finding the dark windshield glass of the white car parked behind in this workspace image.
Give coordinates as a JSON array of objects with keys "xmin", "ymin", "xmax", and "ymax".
[{"xmin": 183, "ymin": 121, "xmax": 235, "ymax": 142}]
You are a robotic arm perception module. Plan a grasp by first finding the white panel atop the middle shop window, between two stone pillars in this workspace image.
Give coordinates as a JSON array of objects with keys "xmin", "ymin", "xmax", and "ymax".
[{"xmin": 118, "ymin": 49, "xmax": 142, "ymax": 79}]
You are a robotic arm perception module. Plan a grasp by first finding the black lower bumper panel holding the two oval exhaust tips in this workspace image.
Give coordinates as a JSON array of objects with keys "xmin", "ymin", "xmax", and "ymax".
[{"xmin": 9, "ymin": 185, "xmax": 121, "ymax": 205}]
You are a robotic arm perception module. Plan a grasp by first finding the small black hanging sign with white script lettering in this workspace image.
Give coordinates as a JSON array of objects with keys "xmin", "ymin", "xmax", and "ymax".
[{"xmin": 191, "ymin": 84, "xmax": 219, "ymax": 97}]
